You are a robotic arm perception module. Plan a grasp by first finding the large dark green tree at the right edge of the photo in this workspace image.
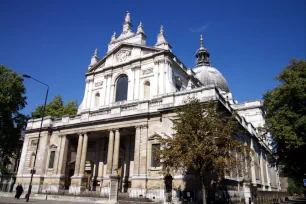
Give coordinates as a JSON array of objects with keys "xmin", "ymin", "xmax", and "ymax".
[{"xmin": 263, "ymin": 59, "xmax": 306, "ymax": 182}]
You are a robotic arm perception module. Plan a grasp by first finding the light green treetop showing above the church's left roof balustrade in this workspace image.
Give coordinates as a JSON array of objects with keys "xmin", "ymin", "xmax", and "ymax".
[{"xmin": 32, "ymin": 95, "xmax": 78, "ymax": 118}]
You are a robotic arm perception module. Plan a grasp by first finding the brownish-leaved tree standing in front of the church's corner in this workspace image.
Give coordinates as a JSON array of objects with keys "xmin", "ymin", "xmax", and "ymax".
[{"xmin": 157, "ymin": 98, "xmax": 251, "ymax": 203}]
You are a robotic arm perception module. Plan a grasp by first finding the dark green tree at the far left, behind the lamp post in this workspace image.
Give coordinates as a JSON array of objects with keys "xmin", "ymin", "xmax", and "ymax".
[{"xmin": 0, "ymin": 65, "xmax": 27, "ymax": 165}]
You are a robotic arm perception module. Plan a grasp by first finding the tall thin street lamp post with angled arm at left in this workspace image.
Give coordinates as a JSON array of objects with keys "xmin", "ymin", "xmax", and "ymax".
[{"xmin": 22, "ymin": 74, "xmax": 49, "ymax": 202}]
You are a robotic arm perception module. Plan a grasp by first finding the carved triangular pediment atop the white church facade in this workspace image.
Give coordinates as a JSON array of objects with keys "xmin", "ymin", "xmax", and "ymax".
[{"xmin": 88, "ymin": 42, "xmax": 165, "ymax": 73}]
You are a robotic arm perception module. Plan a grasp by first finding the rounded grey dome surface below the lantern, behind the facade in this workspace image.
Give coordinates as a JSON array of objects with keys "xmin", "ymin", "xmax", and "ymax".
[{"xmin": 193, "ymin": 66, "xmax": 229, "ymax": 92}]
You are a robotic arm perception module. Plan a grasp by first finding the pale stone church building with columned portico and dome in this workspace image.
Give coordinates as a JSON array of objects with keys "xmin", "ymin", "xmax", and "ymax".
[{"xmin": 16, "ymin": 12, "xmax": 280, "ymax": 201}]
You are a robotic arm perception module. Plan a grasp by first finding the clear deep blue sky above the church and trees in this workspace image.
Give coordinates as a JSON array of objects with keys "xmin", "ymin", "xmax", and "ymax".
[{"xmin": 0, "ymin": 0, "xmax": 306, "ymax": 114}]
